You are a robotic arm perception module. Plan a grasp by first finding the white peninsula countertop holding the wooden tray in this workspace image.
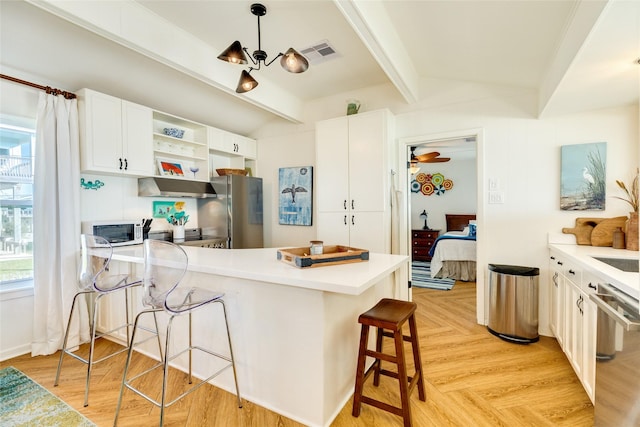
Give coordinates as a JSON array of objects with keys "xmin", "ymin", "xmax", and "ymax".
[{"xmin": 113, "ymin": 245, "xmax": 409, "ymax": 295}]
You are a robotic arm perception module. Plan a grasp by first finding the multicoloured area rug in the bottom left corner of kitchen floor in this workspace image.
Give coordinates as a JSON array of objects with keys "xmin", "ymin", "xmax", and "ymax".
[{"xmin": 0, "ymin": 366, "xmax": 95, "ymax": 427}]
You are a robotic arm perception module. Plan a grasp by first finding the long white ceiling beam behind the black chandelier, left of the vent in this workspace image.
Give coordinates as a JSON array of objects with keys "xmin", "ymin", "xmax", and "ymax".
[{"xmin": 26, "ymin": 0, "xmax": 302, "ymax": 123}]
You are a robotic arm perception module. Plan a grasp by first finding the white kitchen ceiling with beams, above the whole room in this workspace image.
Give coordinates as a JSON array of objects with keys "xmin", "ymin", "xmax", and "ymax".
[{"xmin": 0, "ymin": 0, "xmax": 640, "ymax": 138}]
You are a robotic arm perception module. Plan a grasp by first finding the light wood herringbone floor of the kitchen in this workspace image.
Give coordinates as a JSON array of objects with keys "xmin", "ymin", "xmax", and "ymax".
[{"xmin": 0, "ymin": 282, "xmax": 593, "ymax": 427}]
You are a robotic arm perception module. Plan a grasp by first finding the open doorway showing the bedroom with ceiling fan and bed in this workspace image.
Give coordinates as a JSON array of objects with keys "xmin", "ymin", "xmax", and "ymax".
[{"xmin": 400, "ymin": 129, "xmax": 486, "ymax": 324}]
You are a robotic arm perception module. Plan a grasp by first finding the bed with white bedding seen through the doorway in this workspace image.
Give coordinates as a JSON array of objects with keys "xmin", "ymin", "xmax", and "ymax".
[{"xmin": 429, "ymin": 214, "xmax": 476, "ymax": 282}]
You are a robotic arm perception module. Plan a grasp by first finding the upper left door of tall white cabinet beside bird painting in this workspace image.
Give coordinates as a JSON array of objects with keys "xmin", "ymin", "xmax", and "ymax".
[{"xmin": 315, "ymin": 117, "xmax": 350, "ymax": 212}]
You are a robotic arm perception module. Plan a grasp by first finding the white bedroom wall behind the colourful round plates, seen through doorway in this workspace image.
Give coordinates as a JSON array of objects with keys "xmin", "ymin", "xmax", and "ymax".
[{"xmin": 411, "ymin": 158, "xmax": 477, "ymax": 233}]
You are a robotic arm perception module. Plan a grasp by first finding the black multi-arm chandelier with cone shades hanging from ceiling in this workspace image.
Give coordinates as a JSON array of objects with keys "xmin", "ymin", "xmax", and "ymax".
[{"xmin": 218, "ymin": 3, "xmax": 309, "ymax": 93}]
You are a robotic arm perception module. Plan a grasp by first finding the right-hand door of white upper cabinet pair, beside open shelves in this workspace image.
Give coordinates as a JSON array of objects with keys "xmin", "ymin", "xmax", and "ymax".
[{"xmin": 122, "ymin": 101, "xmax": 155, "ymax": 176}]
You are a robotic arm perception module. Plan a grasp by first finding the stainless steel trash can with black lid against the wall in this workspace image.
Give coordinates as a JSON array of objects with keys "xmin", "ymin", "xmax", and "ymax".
[{"xmin": 487, "ymin": 264, "xmax": 540, "ymax": 344}]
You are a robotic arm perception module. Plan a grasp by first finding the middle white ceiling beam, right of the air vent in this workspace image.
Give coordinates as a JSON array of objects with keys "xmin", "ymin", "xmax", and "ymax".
[{"xmin": 334, "ymin": 0, "xmax": 420, "ymax": 104}]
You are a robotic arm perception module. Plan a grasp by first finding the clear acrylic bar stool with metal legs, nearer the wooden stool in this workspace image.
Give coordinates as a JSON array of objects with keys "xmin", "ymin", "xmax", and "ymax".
[{"xmin": 113, "ymin": 239, "xmax": 242, "ymax": 426}]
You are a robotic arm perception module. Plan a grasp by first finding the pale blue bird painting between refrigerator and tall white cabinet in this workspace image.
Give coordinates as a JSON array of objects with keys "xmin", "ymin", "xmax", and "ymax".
[{"xmin": 278, "ymin": 166, "xmax": 313, "ymax": 226}]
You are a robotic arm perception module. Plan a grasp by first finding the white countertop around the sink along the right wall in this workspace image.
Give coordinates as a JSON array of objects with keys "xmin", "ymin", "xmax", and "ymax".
[{"xmin": 549, "ymin": 244, "xmax": 640, "ymax": 299}]
